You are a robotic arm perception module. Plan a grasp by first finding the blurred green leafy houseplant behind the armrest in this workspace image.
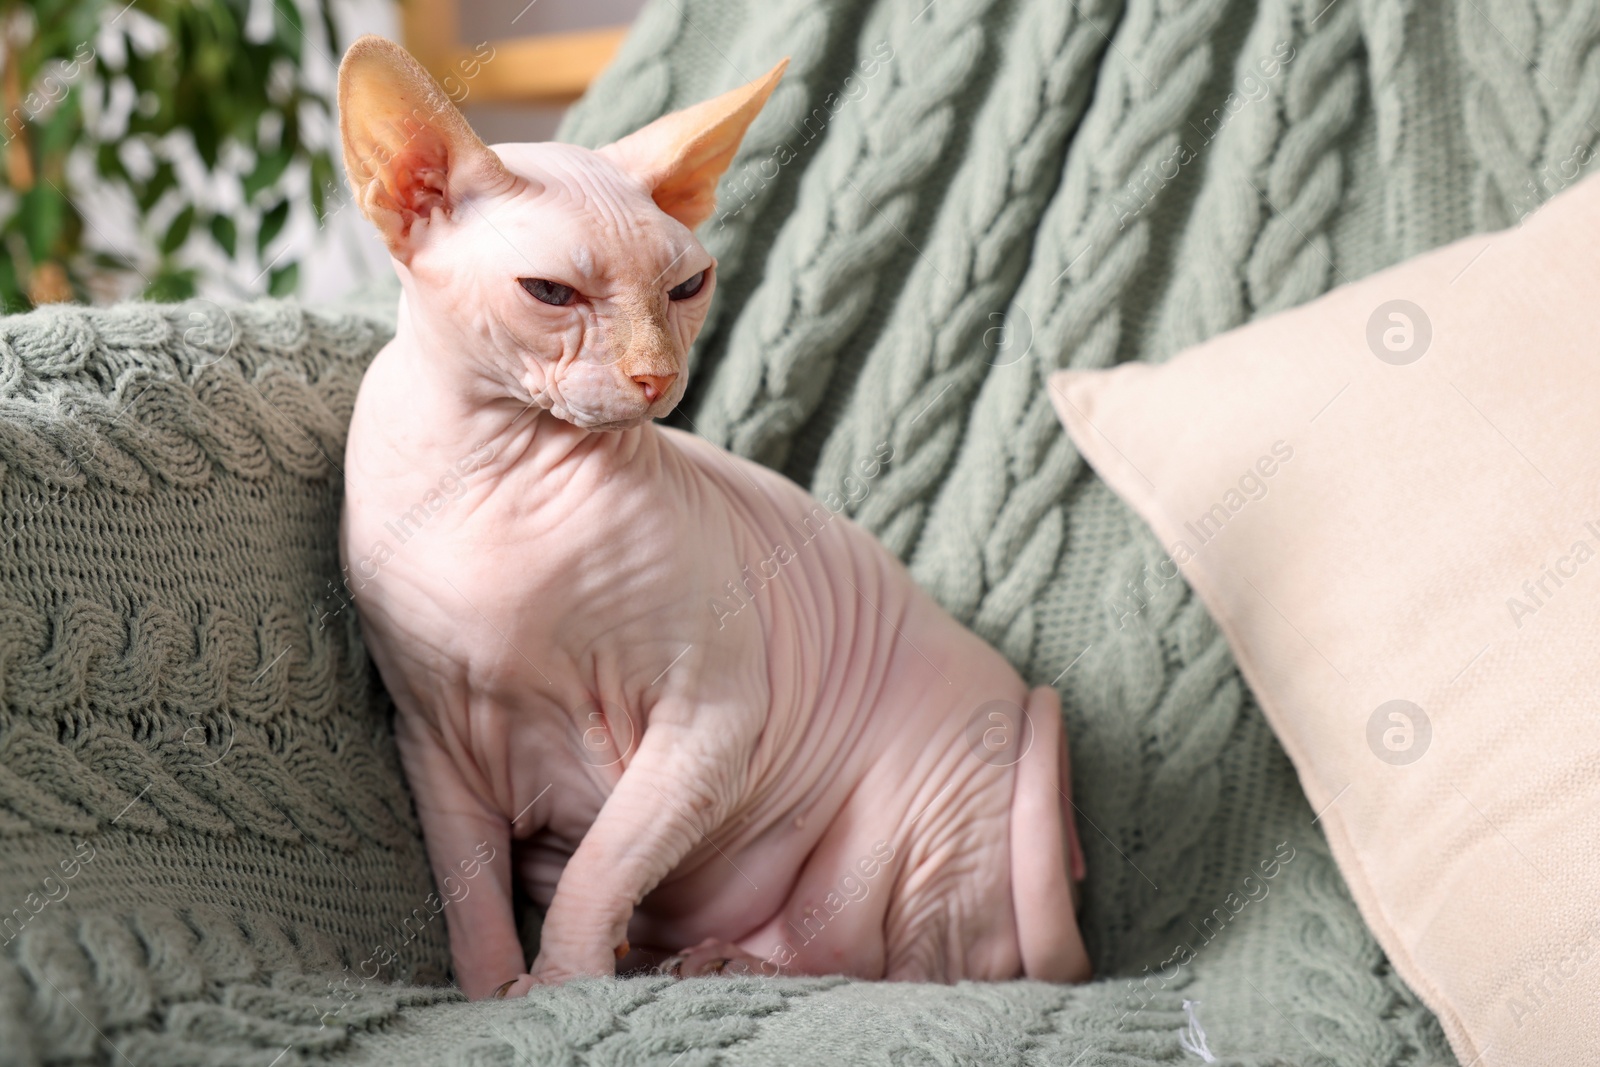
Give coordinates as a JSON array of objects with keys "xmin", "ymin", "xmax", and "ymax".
[{"xmin": 0, "ymin": 0, "xmax": 338, "ymax": 310}]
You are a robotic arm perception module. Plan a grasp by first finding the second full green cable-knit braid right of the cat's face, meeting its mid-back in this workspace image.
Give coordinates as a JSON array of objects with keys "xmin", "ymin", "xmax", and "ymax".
[{"xmin": 813, "ymin": 3, "xmax": 1114, "ymax": 557}]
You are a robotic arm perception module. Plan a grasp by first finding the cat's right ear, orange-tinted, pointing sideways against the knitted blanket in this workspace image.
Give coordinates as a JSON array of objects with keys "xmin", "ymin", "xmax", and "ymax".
[{"xmin": 600, "ymin": 59, "xmax": 789, "ymax": 230}]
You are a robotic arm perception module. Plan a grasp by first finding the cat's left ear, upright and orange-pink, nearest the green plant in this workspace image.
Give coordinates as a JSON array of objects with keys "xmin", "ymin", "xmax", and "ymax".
[{"xmin": 339, "ymin": 35, "xmax": 517, "ymax": 262}]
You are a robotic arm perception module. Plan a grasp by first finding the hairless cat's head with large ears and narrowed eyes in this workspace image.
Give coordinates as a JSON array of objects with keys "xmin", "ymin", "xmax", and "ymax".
[{"xmin": 339, "ymin": 37, "xmax": 786, "ymax": 430}]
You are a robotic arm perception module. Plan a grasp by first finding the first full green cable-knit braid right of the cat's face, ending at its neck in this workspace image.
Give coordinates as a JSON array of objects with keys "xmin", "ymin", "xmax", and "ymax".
[{"xmin": 694, "ymin": 0, "xmax": 995, "ymax": 464}]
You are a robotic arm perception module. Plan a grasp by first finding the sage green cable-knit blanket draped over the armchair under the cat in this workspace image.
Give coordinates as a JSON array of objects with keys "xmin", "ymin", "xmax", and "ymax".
[{"xmin": 0, "ymin": 0, "xmax": 1574, "ymax": 1067}]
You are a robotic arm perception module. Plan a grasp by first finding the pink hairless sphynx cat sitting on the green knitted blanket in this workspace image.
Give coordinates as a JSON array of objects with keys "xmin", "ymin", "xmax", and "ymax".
[{"xmin": 339, "ymin": 37, "xmax": 1090, "ymax": 997}]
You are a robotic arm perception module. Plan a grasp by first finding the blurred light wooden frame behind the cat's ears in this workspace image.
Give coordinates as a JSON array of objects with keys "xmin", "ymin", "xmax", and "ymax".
[{"xmin": 400, "ymin": 0, "xmax": 627, "ymax": 104}]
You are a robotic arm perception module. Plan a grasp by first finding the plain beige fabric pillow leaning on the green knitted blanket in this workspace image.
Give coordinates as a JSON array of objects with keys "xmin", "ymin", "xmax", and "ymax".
[{"xmin": 1050, "ymin": 178, "xmax": 1600, "ymax": 1067}]
